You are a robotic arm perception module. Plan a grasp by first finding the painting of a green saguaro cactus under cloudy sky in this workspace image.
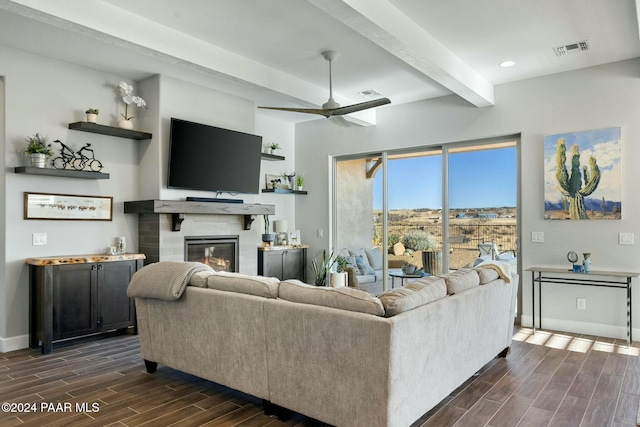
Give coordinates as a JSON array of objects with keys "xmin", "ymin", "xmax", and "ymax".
[{"xmin": 544, "ymin": 127, "xmax": 622, "ymax": 220}]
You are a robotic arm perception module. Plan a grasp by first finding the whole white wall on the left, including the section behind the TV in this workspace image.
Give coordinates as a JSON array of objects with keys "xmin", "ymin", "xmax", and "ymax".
[{"xmin": 0, "ymin": 46, "xmax": 295, "ymax": 352}]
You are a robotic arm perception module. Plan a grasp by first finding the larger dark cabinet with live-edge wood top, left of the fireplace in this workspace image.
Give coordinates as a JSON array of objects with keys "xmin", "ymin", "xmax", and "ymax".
[{"xmin": 27, "ymin": 254, "xmax": 144, "ymax": 354}]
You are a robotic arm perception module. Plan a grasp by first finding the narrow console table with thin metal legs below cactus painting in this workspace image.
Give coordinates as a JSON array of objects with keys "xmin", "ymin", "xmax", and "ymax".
[{"xmin": 526, "ymin": 267, "xmax": 640, "ymax": 346}]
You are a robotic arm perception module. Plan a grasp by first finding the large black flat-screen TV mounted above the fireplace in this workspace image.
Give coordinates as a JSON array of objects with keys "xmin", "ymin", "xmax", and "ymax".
[{"xmin": 167, "ymin": 118, "xmax": 262, "ymax": 194}]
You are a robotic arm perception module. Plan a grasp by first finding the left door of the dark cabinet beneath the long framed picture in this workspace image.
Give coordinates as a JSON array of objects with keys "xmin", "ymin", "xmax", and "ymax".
[{"xmin": 53, "ymin": 264, "xmax": 98, "ymax": 340}]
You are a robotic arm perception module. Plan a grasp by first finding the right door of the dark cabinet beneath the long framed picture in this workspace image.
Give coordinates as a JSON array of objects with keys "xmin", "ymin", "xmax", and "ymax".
[{"xmin": 97, "ymin": 261, "xmax": 136, "ymax": 331}]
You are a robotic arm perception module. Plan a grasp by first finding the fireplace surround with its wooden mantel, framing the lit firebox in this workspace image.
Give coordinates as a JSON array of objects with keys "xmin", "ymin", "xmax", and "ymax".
[{"xmin": 124, "ymin": 200, "xmax": 275, "ymax": 274}]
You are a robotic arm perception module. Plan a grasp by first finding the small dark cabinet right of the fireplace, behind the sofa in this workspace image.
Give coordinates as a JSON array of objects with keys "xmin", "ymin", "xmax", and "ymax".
[{"xmin": 258, "ymin": 247, "xmax": 307, "ymax": 282}]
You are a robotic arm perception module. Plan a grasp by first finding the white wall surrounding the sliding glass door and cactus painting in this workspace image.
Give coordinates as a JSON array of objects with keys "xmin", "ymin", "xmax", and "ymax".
[{"xmin": 296, "ymin": 59, "xmax": 640, "ymax": 338}]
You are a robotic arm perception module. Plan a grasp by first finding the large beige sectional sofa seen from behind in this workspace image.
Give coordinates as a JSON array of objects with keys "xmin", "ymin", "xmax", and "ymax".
[{"xmin": 128, "ymin": 262, "xmax": 518, "ymax": 427}]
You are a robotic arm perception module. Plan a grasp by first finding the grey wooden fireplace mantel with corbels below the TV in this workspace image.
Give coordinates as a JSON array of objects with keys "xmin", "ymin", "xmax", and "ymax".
[{"xmin": 124, "ymin": 200, "xmax": 276, "ymax": 231}]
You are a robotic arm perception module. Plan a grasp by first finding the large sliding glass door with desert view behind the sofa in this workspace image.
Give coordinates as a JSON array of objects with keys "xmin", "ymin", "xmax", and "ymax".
[{"xmin": 333, "ymin": 140, "xmax": 518, "ymax": 296}]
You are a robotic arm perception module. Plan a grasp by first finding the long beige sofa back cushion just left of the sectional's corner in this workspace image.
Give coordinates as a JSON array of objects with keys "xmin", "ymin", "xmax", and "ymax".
[{"xmin": 278, "ymin": 279, "xmax": 384, "ymax": 316}]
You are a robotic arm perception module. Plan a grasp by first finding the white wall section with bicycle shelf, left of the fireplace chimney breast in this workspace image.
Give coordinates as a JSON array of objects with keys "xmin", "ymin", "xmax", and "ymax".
[{"xmin": 0, "ymin": 46, "xmax": 138, "ymax": 351}]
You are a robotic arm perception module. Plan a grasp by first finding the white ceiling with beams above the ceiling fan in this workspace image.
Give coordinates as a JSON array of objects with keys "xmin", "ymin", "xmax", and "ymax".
[{"xmin": 0, "ymin": 0, "xmax": 640, "ymax": 122}]
